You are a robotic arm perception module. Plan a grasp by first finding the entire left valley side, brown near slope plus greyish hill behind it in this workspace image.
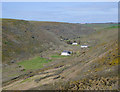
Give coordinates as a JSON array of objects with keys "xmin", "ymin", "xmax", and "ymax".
[{"xmin": 2, "ymin": 19, "xmax": 94, "ymax": 62}]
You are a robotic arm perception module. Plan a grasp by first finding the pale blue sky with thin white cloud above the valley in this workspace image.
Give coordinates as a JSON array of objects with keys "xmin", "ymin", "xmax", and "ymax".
[{"xmin": 2, "ymin": 2, "xmax": 118, "ymax": 23}]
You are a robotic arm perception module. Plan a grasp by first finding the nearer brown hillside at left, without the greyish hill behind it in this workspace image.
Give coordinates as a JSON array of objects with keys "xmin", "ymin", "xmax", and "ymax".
[{"xmin": 2, "ymin": 19, "xmax": 61, "ymax": 63}]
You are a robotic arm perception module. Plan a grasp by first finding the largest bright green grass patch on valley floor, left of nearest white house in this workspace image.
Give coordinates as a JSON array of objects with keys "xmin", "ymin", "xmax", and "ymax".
[{"xmin": 18, "ymin": 57, "xmax": 52, "ymax": 70}]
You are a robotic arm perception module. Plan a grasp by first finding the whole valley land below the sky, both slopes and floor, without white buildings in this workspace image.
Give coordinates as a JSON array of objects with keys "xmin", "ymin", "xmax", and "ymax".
[{"xmin": 3, "ymin": 19, "xmax": 120, "ymax": 90}]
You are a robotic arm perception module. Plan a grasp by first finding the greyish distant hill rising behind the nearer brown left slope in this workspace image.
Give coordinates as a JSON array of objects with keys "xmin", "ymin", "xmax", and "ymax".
[{"xmin": 31, "ymin": 21, "xmax": 95, "ymax": 39}]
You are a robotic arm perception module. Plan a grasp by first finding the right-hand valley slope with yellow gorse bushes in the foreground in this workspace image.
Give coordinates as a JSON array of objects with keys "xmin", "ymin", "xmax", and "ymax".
[{"xmin": 31, "ymin": 23, "xmax": 117, "ymax": 90}]
